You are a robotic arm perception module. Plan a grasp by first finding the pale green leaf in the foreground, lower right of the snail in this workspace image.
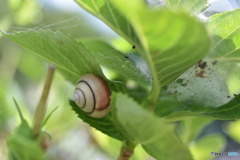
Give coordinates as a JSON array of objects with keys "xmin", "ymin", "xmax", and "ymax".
[{"xmin": 112, "ymin": 93, "xmax": 192, "ymax": 160}]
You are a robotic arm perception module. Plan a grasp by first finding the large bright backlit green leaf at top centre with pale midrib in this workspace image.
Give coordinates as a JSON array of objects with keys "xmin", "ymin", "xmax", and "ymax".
[{"xmin": 76, "ymin": 0, "xmax": 210, "ymax": 103}]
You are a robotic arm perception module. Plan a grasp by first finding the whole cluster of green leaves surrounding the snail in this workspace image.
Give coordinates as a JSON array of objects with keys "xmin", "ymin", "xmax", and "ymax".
[{"xmin": 3, "ymin": 0, "xmax": 240, "ymax": 160}]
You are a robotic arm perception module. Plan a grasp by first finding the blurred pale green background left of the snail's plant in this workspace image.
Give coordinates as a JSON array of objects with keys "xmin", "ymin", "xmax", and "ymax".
[{"xmin": 0, "ymin": 0, "xmax": 151, "ymax": 160}]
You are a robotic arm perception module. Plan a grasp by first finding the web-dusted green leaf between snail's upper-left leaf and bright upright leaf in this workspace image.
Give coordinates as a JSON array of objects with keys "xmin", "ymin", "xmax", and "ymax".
[{"xmin": 82, "ymin": 40, "xmax": 150, "ymax": 87}]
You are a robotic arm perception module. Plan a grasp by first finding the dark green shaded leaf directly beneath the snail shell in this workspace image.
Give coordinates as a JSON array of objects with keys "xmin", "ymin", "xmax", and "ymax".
[{"xmin": 70, "ymin": 101, "xmax": 124, "ymax": 140}]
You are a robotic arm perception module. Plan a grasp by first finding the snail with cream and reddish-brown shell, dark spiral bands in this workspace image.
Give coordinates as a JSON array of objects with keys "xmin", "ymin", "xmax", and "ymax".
[{"xmin": 73, "ymin": 74, "xmax": 111, "ymax": 118}]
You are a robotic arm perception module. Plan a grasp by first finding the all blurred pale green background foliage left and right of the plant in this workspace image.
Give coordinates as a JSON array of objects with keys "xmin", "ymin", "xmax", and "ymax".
[{"xmin": 0, "ymin": 0, "xmax": 240, "ymax": 160}]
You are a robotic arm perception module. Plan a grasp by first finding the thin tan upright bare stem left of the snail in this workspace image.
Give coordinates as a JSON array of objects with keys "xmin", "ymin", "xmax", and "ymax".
[{"xmin": 33, "ymin": 65, "xmax": 55, "ymax": 137}]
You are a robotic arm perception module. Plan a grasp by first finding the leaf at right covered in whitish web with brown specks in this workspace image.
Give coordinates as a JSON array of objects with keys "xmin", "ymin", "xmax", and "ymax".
[{"xmin": 155, "ymin": 60, "xmax": 236, "ymax": 120}]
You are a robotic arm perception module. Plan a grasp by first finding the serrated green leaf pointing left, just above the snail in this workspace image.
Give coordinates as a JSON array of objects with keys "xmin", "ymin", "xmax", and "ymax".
[{"xmin": 2, "ymin": 30, "xmax": 103, "ymax": 83}]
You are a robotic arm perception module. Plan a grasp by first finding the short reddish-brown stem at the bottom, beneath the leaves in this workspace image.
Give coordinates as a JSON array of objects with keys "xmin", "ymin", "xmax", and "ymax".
[{"xmin": 117, "ymin": 141, "xmax": 136, "ymax": 160}]
